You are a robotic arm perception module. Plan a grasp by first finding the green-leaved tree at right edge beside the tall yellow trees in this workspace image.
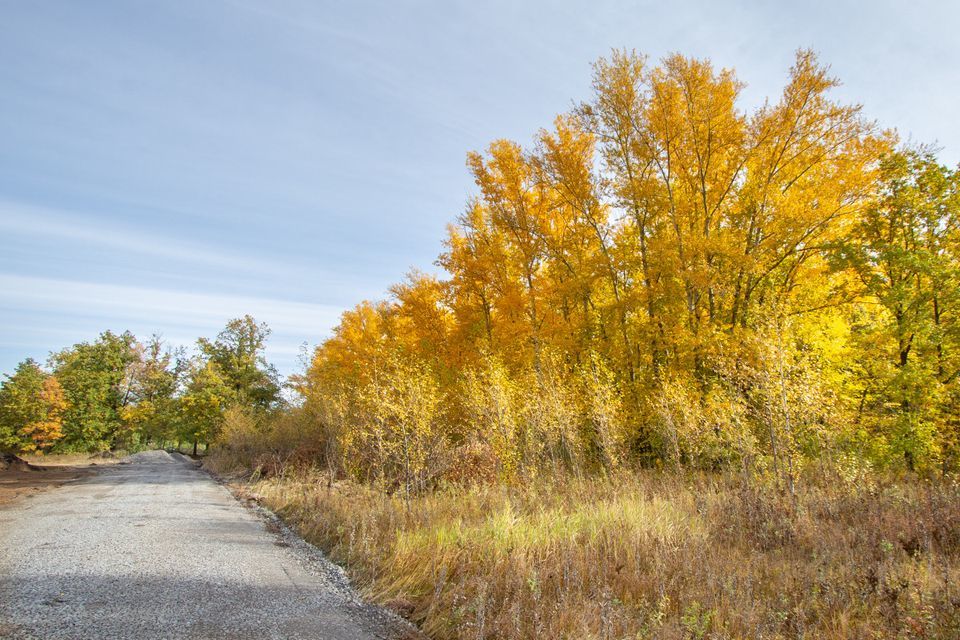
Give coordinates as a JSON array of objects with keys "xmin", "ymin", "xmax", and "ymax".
[{"xmin": 840, "ymin": 149, "xmax": 960, "ymax": 468}]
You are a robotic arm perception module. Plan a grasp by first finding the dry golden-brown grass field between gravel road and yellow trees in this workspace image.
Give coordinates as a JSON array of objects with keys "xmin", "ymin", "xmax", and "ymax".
[{"xmin": 218, "ymin": 462, "xmax": 960, "ymax": 639}]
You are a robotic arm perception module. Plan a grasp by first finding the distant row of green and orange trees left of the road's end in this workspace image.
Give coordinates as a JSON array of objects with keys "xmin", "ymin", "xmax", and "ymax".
[{"xmin": 0, "ymin": 316, "xmax": 280, "ymax": 454}]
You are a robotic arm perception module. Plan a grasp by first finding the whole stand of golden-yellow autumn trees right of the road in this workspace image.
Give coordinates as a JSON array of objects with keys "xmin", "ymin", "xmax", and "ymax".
[{"xmin": 301, "ymin": 51, "xmax": 960, "ymax": 480}]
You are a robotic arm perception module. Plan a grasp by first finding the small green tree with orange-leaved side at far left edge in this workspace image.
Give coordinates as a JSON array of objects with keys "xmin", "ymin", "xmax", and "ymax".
[{"xmin": 0, "ymin": 359, "xmax": 67, "ymax": 453}]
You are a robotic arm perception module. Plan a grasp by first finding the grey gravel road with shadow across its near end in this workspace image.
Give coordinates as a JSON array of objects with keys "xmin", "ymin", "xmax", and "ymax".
[{"xmin": 0, "ymin": 451, "xmax": 409, "ymax": 640}]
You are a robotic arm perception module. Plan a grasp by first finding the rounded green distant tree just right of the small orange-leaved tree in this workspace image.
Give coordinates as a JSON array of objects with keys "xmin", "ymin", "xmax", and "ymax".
[{"xmin": 50, "ymin": 331, "xmax": 138, "ymax": 450}]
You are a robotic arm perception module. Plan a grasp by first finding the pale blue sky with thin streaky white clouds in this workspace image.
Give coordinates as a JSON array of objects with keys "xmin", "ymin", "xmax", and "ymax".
[{"xmin": 0, "ymin": 0, "xmax": 960, "ymax": 374}]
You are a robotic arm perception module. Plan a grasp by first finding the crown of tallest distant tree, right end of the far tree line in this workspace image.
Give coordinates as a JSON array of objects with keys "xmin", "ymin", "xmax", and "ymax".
[{"xmin": 198, "ymin": 315, "xmax": 280, "ymax": 408}]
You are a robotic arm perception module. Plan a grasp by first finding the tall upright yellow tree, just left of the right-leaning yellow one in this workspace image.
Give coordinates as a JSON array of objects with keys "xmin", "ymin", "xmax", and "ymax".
[{"xmin": 581, "ymin": 52, "xmax": 749, "ymax": 382}]
